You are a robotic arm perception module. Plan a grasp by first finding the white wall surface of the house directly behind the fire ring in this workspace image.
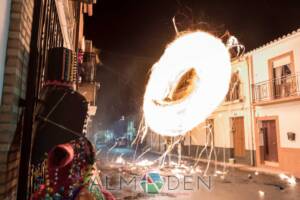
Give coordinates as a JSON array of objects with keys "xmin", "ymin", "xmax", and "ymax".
[{"xmin": 185, "ymin": 60, "xmax": 255, "ymax": 150}]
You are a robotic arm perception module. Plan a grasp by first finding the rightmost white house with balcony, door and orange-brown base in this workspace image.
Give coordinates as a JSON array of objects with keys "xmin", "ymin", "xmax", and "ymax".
[{"xmin": 247, "ymin": 29, "xmax": 300, "ymax": 177}]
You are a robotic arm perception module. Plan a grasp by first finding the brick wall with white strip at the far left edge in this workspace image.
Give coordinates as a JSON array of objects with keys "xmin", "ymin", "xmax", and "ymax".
[{"xmin": 0, "ymin": 0, "xmax": 34, "ymax": 199}]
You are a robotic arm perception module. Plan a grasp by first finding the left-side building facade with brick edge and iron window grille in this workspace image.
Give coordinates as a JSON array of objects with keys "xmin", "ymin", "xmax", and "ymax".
[{"xmin": 0, "ymin": 0, "xmax": 96, "ymax": 199}]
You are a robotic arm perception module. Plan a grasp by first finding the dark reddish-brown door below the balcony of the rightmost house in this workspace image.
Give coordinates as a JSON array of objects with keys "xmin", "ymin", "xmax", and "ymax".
[{"xmin": 262, "ymin": 120, "xmax": 278, "ymax": 162}]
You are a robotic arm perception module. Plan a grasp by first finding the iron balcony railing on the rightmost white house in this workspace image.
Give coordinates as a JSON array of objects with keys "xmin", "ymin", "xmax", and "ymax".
[{"xmin": 253, "ymin": 73, "xmax": 300, "ymax": 103}]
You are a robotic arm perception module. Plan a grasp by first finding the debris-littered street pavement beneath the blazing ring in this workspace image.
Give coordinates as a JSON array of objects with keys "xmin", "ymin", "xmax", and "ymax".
[{"xmin": 97, "ymin": 146, "xmax": 300, "ymax": 200}]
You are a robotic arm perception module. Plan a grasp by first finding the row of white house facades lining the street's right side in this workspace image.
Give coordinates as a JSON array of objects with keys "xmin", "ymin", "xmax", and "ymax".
[{"xmin": 147, "ymin": 29, "xmax": 300, "ymax": 177}]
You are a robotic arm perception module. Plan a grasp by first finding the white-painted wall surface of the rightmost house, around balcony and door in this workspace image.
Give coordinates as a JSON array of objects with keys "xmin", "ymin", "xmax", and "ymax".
[{"xmin": 252, "ymin": 32, "xmax": 300, "ymax": 148}]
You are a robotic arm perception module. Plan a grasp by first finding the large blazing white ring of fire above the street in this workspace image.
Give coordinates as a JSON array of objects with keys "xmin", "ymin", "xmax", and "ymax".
[{"xmin": 143, "ymin": 31, "xmax": 231, "ymax": 136}]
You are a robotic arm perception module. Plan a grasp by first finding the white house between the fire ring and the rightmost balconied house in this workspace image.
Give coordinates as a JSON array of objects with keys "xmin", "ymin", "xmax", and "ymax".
[{"xmin": 185, "ymin": 59, "xmax": 255, "ymax": 164}]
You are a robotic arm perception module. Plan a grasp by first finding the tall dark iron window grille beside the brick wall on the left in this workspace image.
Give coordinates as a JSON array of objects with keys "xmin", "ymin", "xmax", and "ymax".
[{"xmin": 17, "ymin": 0, "xmax": 80, "ymax": 200}]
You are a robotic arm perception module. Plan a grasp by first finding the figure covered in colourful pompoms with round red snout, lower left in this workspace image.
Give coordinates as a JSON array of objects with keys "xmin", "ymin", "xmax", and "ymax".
[{"xmin": 31, "ymin": 137, "xmax": 115, "ymax": 200}]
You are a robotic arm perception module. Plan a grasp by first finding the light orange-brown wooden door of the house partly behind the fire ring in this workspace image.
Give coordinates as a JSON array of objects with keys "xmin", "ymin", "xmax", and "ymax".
[{"xmin": 231, "ymin": 117, "xmax": 245, "ymax": 157}]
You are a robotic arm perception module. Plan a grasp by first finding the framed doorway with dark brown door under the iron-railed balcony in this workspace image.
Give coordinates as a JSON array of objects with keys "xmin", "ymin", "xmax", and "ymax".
[{"xmin": 259, "ymin": 120, "xmax": 278, "ymax": 163}]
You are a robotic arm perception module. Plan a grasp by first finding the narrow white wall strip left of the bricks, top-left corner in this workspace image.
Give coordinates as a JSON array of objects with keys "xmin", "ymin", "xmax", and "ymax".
[{"xmin": 0, "ymin": 0, "xmax": 11, "ymax": 104}]
